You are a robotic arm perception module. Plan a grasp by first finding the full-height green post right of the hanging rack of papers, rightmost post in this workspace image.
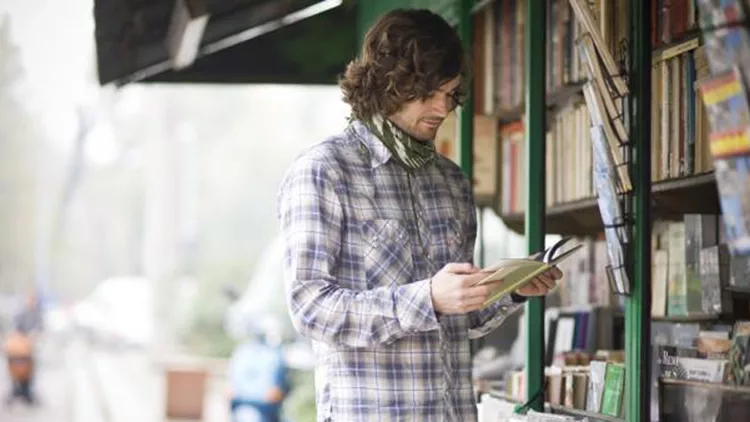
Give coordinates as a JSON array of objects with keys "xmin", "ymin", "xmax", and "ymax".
[{"xmin": 625, "ymin": 1, "xmax": 651, "ymax": 422}]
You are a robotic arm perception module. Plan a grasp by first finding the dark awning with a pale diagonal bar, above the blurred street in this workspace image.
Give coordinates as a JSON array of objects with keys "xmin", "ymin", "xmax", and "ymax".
[{"xmin": 94, "ymin": 0, "xmax": 357, "ymax": 85}]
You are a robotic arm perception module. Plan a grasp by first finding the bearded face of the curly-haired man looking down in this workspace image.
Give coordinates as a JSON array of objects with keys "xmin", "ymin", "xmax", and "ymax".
[{"xmin": 388, "ymin": 76, "xmax": 461, "ymax": 141}]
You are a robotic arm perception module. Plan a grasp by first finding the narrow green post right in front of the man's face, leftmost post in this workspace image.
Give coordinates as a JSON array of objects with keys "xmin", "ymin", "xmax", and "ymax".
[{"xmin": 457, "ymin": 0, "xmax": 474, "ymax": 180}]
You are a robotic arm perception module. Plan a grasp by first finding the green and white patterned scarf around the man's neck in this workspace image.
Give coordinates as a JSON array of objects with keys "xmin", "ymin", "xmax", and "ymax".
[{"xmin": 363, "ymin": 116, "xmax": 437, "ymax": 170}]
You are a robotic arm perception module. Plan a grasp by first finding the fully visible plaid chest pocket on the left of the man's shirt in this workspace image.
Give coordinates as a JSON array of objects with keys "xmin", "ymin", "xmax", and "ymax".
[{"xmin": 362, "ymin": 219, "xmax": 414, "ymax": 289}]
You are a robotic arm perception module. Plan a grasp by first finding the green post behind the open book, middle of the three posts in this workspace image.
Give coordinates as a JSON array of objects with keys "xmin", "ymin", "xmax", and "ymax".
[{"xmin": 525, "ymin": 0, "xmax": 547, "ymax": 411}]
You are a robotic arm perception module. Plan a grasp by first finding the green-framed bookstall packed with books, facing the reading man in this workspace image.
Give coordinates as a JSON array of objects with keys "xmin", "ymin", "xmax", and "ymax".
[{"xmin": 360, "ymin": 0, "xmax": 750, "ymax": 421}]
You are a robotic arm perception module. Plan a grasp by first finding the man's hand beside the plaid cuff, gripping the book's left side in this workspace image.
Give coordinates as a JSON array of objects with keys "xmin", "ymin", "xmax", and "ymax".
[{"xmin": 432, "ymin": 263, "xmax": 496, "ymax": 315}]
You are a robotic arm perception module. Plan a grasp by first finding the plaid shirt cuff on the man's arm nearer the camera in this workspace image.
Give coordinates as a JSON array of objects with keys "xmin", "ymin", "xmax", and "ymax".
[{"xmin": 393, "ymin": 279, "xmax": 440, "ymax": 333}]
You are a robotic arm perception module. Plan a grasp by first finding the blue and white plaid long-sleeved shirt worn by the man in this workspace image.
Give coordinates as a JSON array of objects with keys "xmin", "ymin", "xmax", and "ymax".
[{"xmin": 278, "ymin": 121, "xmax": 519, "ymax": 422}]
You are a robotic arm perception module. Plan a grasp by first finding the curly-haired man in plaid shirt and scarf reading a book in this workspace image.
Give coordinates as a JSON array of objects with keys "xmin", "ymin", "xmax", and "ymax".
[{"xmin": 279, "ymin": 10, "xmax": 562, "ymax": 422}]
